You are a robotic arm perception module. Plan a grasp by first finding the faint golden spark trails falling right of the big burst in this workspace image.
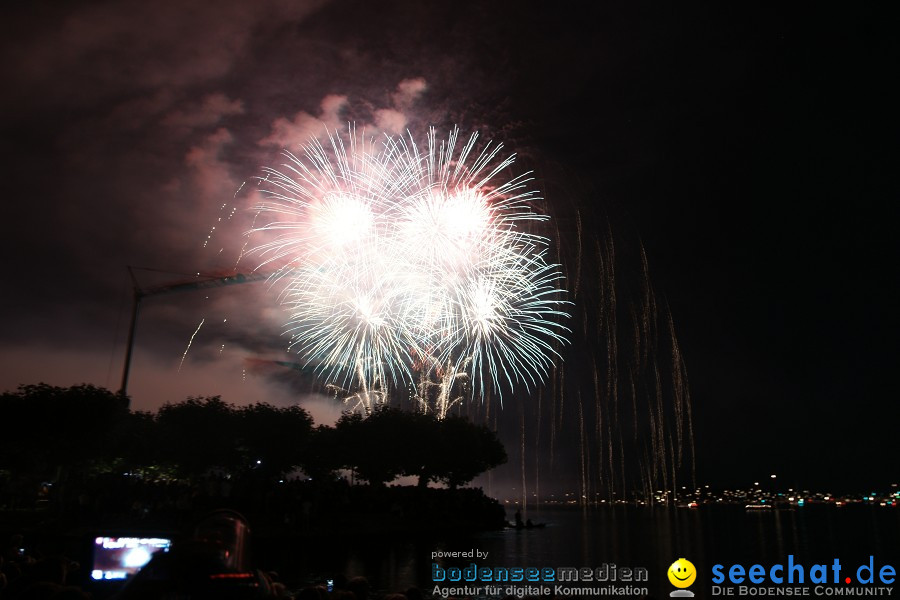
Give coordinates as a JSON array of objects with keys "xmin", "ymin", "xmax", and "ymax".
[{"xmin": 529, "ymin": 213, "xmax": 696, "ymax": 503}]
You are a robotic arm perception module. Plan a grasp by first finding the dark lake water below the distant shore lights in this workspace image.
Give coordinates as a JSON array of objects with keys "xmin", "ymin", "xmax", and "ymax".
[{"xmin": 257, "ymin": 506, "xmax": 900, "ymax": 597}]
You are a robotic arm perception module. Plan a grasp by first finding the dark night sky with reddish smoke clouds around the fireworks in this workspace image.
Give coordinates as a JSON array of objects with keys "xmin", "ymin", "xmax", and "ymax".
[{"xmin": 0, "ymin": 0, "xmax": 900, "ymax": 488}]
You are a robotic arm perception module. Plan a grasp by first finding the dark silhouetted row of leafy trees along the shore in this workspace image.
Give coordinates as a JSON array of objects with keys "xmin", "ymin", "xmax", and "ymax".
[{"xmin": 0, "ymin": 384, "xmax": 507, "ymax": 488}]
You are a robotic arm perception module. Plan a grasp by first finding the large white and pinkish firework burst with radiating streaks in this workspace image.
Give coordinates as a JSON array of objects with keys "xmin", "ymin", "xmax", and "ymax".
[{"xmin": 251, "ymin": 124, "xmax": 568, "ymax": 413}]
